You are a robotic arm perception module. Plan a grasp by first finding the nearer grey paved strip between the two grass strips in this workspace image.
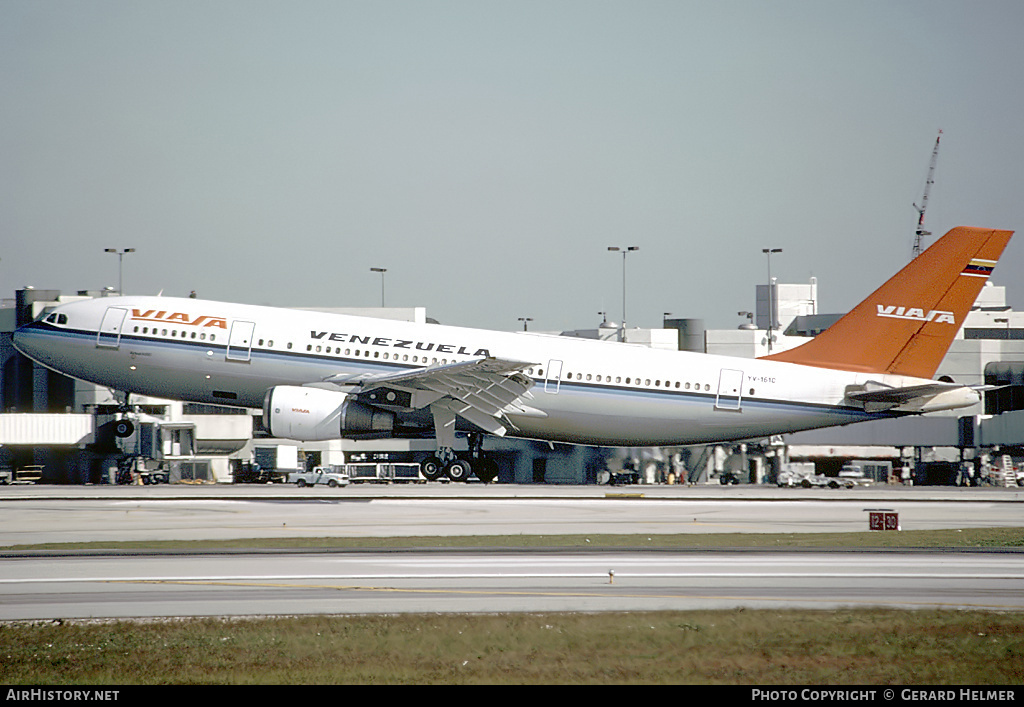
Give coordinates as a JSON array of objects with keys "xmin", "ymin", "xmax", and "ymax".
[{"xmin": 0, "ymin": 550, "xmax": 1024, "ymax": 620}]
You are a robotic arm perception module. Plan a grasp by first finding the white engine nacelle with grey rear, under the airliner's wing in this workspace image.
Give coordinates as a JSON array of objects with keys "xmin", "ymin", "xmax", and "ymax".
[{"xmin": 263, "ymin": 385, "xmax": 394, "ymax": 442}]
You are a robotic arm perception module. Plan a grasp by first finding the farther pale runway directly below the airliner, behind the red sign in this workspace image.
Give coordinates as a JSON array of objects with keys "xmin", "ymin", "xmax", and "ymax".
[{"xmin": 0, "ymin": 484, "xmax": 1024, "ymax": 548}]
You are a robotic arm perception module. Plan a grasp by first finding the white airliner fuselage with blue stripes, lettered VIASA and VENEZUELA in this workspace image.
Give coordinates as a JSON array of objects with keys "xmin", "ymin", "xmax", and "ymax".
[{"xmin": 15, "ymin": 297, "xmax": 962, "ymax": 446}]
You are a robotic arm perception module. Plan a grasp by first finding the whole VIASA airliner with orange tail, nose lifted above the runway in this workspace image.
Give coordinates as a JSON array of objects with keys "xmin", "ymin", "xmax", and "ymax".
[{"xmin": 14, "ymin": 227, "xmax": 1012, "ymax": 481}]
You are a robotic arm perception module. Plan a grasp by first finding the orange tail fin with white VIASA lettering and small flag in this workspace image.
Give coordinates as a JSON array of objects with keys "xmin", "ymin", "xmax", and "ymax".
[{"xmin": 764, "ymin": 226, "xmax": 1013, "ymax": 378}]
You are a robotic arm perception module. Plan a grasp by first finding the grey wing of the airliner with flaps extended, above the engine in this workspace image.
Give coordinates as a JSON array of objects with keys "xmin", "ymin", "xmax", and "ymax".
[{"xmin": 324, "ymin": 358, "xmax": 544, "ymax": 435}]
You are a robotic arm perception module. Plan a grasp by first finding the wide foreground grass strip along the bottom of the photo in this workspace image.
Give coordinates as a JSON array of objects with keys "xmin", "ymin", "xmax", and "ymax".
[{"xmin": 0, "ymin": 610, "xmax": 1024, "ymax": 685}]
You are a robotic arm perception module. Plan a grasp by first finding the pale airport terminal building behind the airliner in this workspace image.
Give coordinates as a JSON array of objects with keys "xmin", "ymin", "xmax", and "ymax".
[{"xmin": 0, "ymin": 279, "xmax": 1024, "ymax": 484}]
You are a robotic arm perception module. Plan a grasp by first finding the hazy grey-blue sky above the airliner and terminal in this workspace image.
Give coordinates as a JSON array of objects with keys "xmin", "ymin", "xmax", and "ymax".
[{"xmin": 0, "ymin": 0, "xmax": 1024, "ymax": 330}]
